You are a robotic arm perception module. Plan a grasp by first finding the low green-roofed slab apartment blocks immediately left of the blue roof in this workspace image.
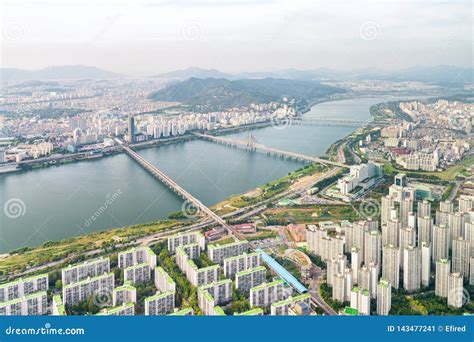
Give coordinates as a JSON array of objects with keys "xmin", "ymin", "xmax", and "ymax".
[{"xmin": 168, "ymin": 232, "xmax": 310, "ymax": 315}]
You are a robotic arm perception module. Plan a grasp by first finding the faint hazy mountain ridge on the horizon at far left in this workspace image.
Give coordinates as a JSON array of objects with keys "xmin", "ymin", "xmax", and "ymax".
[{"xmin": 0, "ymin": 65, "xmax": 121, "ymax": 81}]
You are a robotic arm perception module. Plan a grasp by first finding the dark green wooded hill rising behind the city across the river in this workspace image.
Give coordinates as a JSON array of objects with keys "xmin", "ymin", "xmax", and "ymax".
[{"xmin": 149, "ymin": 77, "xmax": 345, "ymax": 110}]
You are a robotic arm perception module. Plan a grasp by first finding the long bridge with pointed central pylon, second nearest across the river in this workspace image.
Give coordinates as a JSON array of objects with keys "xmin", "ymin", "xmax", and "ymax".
[{"xmin": 195, "ymin": 133, "xmax": 349, "ymax": 168}]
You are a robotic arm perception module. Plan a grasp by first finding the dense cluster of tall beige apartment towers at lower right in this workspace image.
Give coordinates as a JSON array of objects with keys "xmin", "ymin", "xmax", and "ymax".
[{"xmin": 307, "ymin": 175, "xmax": 474, "ymax": 315}]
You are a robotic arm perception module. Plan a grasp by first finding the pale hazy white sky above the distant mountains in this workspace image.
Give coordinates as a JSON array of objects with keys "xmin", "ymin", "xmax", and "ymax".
[{"xmin": 0, "ymin": 0, "xmax": 473, "ymax": 75}]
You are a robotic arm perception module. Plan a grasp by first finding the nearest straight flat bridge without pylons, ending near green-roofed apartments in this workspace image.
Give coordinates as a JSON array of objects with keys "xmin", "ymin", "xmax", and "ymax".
[{"xmin": 121, "ymin": 144, "xmax": 241, "ymax": 239}]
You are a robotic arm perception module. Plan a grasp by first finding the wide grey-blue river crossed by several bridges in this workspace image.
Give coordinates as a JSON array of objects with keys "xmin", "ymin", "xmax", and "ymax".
[{"xmin": 0, "ymin": 98, "xmax": 418, "ymax": 253}]
